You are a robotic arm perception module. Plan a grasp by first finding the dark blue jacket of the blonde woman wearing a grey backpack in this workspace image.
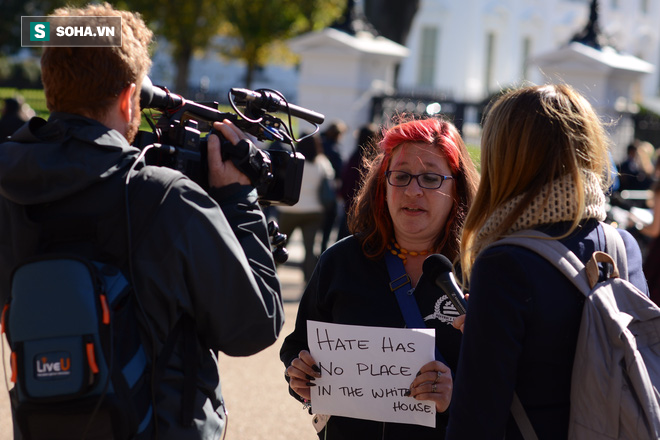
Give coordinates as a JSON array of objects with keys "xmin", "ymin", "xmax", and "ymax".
[{"xmin": 446, "ymin": 220, "xmax": 648, "ymax": 440}]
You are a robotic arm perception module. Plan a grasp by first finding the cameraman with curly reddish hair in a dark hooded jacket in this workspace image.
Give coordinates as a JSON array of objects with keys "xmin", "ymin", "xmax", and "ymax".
[{"xmin": 0, "ymin": 3, "xmax": 283, "ymax": 440}]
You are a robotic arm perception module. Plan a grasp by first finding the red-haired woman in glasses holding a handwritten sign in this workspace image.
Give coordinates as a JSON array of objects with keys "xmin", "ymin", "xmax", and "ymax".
[{"xmin": 280, "ymin": 118, "xmax": 479, "ymax": 439}]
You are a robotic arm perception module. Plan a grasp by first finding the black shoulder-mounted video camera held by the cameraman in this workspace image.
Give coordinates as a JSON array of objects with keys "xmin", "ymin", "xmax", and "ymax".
[{"xmin": 135, "ymin": 76, "xmax": 325, "ymax": 205}]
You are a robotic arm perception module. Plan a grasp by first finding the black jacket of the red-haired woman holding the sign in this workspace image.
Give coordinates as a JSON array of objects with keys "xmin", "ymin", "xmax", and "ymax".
[{"xmin": 280, "ymin": 236, "xmax": 461, "ymax": 440}]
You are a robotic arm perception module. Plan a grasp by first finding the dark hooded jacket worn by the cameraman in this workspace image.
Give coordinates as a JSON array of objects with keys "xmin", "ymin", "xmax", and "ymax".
[{"xmin": 0, "ymin": 113, "xmax": 283, "ymax": 439}]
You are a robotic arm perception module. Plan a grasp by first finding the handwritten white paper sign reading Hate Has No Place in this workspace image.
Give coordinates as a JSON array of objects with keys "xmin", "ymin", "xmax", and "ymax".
[{"xmin": 307, "ymin": 321, "xmax": 435, "ymax": 427}]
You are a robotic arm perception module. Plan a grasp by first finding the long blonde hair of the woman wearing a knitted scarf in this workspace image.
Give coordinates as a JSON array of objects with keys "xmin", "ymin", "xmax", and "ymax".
[{"xmin": 460, "ymin": 84, "xmax": 611, "ymax": 283}]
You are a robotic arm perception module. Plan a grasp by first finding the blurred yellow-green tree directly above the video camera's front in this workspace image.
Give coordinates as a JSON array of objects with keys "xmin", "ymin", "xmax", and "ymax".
[{"xmin": 219, "ymin": 0, "xmax": 346, "ymax": 88}]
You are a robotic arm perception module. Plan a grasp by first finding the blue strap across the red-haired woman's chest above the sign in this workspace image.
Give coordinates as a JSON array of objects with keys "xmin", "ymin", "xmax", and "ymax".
[{"xmin": 385, "ymin": 251, "xmax": 448, "ymax": 365}]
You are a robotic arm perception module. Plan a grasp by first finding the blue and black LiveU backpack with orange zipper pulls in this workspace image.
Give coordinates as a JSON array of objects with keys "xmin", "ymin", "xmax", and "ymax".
[{"xmin": 3, "ymin": 254, "xmax": 153, "ymax": 440}]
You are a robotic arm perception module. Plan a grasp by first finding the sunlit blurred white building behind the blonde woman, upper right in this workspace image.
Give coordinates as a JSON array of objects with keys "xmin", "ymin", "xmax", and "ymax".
[{"xmin": 399, "ymin": 0, "xmax": 660, "ymax": 102}]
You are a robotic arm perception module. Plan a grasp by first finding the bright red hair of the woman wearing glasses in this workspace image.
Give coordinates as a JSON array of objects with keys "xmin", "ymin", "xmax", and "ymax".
[{"xmin": 349, "ymin": 117, "xmax": 479, "ymax": 259}]
